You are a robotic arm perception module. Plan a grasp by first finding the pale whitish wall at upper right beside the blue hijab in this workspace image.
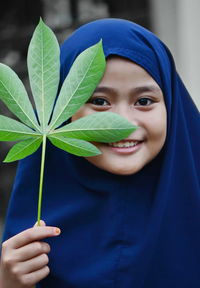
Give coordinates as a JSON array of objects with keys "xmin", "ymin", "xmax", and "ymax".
[{"xmin": 150, "ymin": 0, "xmax": 200, "ymax": 110}]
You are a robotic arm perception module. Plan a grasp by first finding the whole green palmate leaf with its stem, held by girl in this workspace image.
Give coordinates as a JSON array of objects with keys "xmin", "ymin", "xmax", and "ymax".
[{"xmin": 0, "ymin": 20, "xmax": 136, "ymax": 223}]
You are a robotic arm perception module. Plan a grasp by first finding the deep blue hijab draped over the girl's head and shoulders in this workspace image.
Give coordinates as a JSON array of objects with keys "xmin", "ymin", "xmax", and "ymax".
[{"xmin": 1, "ymin": 19, "xmax": 200, "ymax": 288}]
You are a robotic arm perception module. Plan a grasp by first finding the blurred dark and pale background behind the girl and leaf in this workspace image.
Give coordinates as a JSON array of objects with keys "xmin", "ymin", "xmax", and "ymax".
[{"xmin": 0, "ymin": 0, "xmax": 200, "ymax": 239}]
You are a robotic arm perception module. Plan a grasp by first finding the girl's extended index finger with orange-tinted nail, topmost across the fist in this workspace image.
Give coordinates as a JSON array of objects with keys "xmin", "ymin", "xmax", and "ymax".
[{"xmin": 2, "ymin": 226, "xmax": 61, "ymax": 249}]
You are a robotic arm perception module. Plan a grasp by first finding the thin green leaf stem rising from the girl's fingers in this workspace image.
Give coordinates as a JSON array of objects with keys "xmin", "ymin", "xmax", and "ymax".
[{"xmin": 37, "ymin": 135, "xmax": 46, "ymax": 226}]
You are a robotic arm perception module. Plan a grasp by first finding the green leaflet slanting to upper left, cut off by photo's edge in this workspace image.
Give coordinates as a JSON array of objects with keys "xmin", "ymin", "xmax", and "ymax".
[{"xmin": 0, "ymin": 63, "xmax": 39, "ymax": 130}]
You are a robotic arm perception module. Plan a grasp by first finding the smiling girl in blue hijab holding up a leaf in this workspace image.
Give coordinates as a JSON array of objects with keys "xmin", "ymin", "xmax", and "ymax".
[{"xmin": 0, "ymin": 19, "xmax": 200, "ymax": 288}]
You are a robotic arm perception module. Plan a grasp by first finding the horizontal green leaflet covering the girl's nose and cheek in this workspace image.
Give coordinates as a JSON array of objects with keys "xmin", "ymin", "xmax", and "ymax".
[{"xmin": 51, "ymin": 112, "xmax": 137, "ymax": 143}]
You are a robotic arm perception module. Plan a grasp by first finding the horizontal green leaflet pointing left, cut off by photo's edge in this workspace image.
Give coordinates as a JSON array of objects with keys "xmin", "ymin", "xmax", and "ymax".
[{"xmin": 0, "ymin": 115, "xmax": 40, "ymax": 141}]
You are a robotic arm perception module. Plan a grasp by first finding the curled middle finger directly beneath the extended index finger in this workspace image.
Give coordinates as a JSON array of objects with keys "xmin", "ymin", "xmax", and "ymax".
[{"xmin": 12, "ymin": 241, "xmax": 51, "ymax": 262}]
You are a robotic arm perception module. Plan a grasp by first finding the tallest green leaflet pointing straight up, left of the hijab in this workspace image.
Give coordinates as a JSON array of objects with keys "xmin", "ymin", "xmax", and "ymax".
[{"xmin": 27, "ymin": 20, "xmax": 60, "ymax": 131}]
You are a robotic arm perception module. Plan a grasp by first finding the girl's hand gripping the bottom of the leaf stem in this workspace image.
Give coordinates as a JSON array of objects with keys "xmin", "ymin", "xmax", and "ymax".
[{"xmin": 0, "ymin": 221, "xmax": 60, "ymax": 288}]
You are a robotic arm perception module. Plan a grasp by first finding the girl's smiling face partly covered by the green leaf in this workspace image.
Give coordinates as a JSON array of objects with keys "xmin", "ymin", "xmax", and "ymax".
[{"xmin": 72, "ymin": 56, "xmax": 167, "ymax": 175}]
